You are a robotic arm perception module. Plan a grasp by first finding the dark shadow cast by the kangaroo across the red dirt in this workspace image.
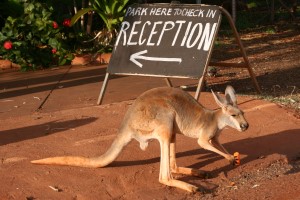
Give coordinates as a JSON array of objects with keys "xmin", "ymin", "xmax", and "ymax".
[{"xmin": 110, "ymin": 129, "xmax": 300, "ymax": 176}]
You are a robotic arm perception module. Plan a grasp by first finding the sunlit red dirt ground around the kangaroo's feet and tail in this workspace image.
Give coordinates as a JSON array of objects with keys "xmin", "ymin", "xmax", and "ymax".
[{"xmin": 0, "ymin": 88, "xmax": 300, "ymax": 199}]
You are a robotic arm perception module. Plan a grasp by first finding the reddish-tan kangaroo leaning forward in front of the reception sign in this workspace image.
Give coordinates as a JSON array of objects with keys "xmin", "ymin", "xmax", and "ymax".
[{"xmin": 31, "ymin": 86, "xmax": 249, "ymax": 192}]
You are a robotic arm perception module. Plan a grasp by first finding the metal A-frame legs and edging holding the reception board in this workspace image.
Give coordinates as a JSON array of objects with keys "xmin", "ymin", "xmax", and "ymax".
[{"xmin": 97, "ymin": 4, "xmax": 261, "ymax": 105}]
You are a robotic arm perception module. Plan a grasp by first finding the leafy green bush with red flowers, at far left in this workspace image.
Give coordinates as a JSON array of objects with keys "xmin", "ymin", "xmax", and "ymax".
[{"xmin": 0, "ymin": 0, "xmax": 75, "ymax": 70}]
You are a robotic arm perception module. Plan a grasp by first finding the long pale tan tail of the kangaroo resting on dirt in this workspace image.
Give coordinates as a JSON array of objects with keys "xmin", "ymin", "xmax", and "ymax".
[{"xmin": 31, "ymin": 132, "xmax": 132, "ymax": 168}]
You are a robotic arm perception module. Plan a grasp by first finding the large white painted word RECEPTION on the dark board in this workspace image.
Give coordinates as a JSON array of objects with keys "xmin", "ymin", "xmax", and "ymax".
[{"xmin": 115, "ymin": 20, "xmax": 217, "ymax": 51}]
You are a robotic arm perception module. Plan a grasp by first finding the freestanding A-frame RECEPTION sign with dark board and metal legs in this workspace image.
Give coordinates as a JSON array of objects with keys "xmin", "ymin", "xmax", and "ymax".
[{"xmin": 97, "ymin": 4, "xmax": 260, "ymax": 104}]
